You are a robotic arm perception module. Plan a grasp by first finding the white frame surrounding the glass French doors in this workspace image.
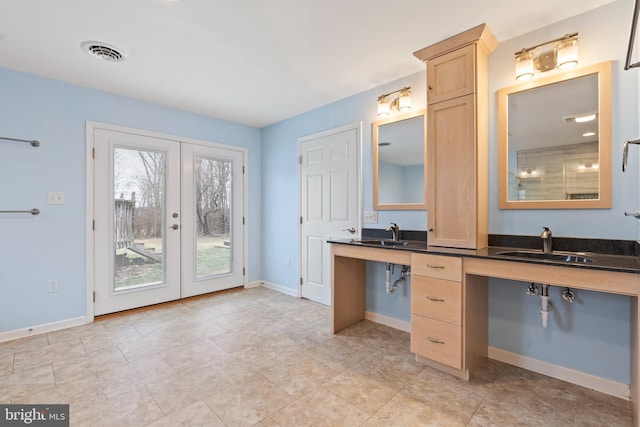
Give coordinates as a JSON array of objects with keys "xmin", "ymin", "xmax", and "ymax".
[{"xmin": 85, "ymin": 120, "xmax": 250, "ymax": 323}]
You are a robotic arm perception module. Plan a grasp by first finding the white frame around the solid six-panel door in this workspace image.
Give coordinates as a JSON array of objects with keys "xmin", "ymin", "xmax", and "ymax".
[{"xmin": 298, "ymin": 122, "xmax": 362, "ymax": 298}]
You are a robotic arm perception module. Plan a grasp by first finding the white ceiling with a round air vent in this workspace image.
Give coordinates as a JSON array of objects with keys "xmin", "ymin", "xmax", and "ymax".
[{"xmin": 0, "ymin": 0, "xmax": 612, "ymax": 127}]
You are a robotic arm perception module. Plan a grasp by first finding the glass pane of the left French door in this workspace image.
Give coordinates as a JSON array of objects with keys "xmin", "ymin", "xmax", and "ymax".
[{"xmin": 113, "ymin": 148, "xmax": 166, "ymax": 291}]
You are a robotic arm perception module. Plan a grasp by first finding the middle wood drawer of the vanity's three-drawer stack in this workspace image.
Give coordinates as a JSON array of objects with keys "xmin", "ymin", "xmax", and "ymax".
[{"xmin": 411, "ymin": 276, "xmax": 462, "ymax": 326}]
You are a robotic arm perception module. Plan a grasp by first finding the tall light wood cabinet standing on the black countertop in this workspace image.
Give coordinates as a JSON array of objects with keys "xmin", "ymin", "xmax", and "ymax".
[{"xmin": 414, "ymin": 24, "xmax": 497, "ymax": 249}]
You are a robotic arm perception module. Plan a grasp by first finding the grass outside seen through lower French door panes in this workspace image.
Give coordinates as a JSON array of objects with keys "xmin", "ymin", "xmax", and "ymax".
[{"xmin": 115, "ymin": 237, "xmax": 231, "ymax": 290}]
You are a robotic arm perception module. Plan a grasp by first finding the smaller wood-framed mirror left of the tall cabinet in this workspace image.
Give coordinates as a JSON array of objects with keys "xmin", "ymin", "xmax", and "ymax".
[{"xmin": 371, "ymin": 110, "xmax": 427, "ymax": 210}]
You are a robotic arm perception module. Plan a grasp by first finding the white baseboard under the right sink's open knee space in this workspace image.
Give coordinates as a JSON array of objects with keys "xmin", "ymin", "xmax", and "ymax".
[{"xmin": 487, "ymin": 347, "xmax": 631, "ymax": 400}]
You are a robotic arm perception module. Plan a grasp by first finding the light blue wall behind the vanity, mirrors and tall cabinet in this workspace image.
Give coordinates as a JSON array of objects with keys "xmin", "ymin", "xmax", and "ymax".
[{"xmin": 262, "ymin": 0, "xmax": 640, "ymax": 383}]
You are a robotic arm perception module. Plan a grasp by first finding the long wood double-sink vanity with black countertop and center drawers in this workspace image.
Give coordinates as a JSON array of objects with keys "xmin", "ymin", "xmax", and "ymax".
[{"xmin": 330, "ymin": 239, "xmax": 640, "ymax": 424}]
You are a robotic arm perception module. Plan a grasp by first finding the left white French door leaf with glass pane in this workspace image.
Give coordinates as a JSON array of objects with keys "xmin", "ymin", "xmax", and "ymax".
[{"xmin": 94, "ymin": 129, "xmax": 180, "ymax": 315}]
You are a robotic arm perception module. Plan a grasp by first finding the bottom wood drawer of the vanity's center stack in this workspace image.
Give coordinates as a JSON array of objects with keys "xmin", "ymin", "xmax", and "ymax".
[{"xmin": 411, "ymin": 314, "xmax": 462, "ymax": 369}]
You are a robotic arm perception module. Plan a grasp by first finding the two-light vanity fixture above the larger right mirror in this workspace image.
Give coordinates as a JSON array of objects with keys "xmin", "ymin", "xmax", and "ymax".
[{"xmin": 515, "ymin": 33, "xmax": 580, "ymax": 80}]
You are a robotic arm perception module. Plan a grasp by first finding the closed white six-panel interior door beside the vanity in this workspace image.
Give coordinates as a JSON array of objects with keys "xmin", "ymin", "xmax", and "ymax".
[{"xmin": 300, "ymin": 127, "xmax": 359, "ymax": 305}]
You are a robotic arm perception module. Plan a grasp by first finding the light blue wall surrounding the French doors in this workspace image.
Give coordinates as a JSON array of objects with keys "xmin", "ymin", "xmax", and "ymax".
[{"xmin": 0, "ymin": 68, "xmax": 262, "ymax": 332}]
